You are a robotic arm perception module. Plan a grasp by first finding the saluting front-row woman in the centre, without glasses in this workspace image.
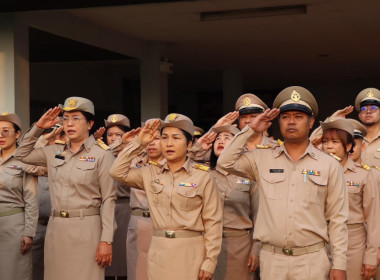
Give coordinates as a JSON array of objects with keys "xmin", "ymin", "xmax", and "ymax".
[{"xmin": 110, "ymin": 114, "xmax": 222, "ymax": 280}]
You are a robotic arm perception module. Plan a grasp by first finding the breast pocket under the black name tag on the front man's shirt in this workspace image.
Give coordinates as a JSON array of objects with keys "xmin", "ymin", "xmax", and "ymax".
[{"xmin": 261, "ymin": 172, "xmax": 286, "ymax": 199}]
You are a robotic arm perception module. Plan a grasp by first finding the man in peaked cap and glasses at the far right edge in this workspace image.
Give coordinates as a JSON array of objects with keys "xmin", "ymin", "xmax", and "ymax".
[{"xmin": 355, "ymin": 88, "xmax": 380, "ymax": 166}]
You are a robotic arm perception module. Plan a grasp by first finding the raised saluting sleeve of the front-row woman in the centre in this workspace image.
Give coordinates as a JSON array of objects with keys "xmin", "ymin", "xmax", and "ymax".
[{"xmin": 110, "ymin": 137, "xmax": 145, "ymax": 189}]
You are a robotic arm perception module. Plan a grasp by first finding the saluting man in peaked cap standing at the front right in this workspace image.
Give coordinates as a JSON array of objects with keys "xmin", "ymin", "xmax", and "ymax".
[{"xmin": 218, "ymin": 86, "xmax": 348, "ymax": 280}]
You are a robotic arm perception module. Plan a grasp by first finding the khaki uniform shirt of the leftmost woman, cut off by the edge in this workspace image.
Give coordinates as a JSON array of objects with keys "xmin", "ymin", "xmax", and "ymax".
[{"xmin": 0, "ymin": 153, "xmax": 38, "ymax": 237}]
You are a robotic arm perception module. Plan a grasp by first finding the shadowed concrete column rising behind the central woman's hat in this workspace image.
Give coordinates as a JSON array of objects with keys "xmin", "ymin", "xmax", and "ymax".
[{"xmin": 140, "ymin": 43, "xmax": 168, "ymax": 121}]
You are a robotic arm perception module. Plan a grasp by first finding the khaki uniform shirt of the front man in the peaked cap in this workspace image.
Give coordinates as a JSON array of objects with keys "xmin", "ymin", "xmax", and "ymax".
[{"xmin": 218, "ymin": 127, "xmax": 348, "ymax": 270}]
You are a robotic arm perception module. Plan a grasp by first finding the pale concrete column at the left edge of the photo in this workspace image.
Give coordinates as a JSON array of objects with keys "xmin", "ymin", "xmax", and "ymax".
[{"xmin": 0, "ymin": 14, "xmax": 30, "ymax": 130}]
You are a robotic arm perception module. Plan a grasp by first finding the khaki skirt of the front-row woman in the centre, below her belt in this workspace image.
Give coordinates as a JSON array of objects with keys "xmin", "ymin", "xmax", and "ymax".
[{"xmin": 148, "ymin": 235, "xmax": 205, "ymax": 280}]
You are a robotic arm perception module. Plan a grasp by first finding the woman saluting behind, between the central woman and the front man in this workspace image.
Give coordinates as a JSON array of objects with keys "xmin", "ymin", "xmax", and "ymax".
[{"xmin": 191, "ymin": 125, "xmax": 259, "ymax": 280}]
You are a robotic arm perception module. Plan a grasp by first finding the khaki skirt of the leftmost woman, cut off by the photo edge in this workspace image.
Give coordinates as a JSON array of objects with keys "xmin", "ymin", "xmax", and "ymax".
[{"xmin": 0, "ymin": 213, "xmax": 32, "ymax": 280}]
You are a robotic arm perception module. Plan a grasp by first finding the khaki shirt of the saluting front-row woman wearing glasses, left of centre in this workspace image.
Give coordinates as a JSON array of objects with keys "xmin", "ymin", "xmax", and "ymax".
[{"xmin": 15, "ymin": 126, "xmax": 116, "ymax": 242}]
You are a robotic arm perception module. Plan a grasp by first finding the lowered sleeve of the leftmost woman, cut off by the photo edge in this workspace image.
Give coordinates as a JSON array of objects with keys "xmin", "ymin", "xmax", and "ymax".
[{"xmin": 22, "ymin": 172, "xmax": 38, "ymax": 237}]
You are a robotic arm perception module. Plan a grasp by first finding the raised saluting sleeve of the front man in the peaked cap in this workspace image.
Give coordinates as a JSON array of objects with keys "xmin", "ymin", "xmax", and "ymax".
[{"xmin": 217, "ymin": 126, "xmax": 257, "ymax": 181}]
